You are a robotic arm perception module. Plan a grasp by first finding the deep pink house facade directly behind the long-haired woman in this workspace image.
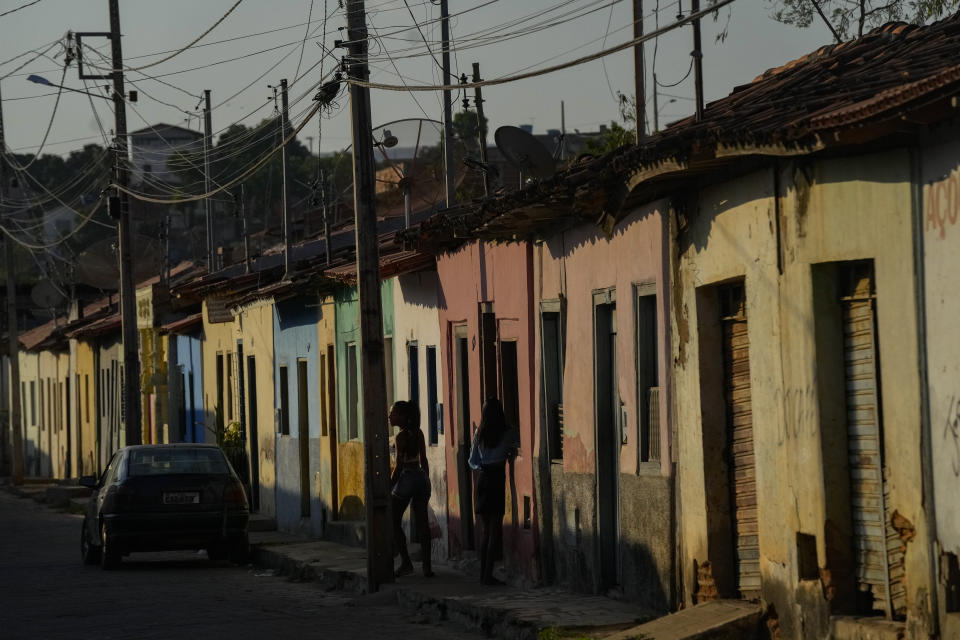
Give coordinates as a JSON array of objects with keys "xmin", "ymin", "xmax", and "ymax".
[{"xmin": 437, "ymin": 242, "xmax": 540, "ymax": 581}]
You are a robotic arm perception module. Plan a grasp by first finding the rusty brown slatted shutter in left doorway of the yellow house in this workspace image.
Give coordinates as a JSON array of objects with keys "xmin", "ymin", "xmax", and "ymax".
[{"xmin": 723, "ymin": 285, "xmax": 760, "ymax": 600}]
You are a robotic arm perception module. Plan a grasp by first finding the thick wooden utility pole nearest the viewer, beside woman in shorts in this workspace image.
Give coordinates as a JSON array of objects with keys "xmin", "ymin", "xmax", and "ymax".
[{"xmin": 347, "ymin": 0, "xmax": 394, "ymax": 591}]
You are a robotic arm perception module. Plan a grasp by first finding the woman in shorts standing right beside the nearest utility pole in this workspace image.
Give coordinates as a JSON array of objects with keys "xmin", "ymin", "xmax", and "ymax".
[{"xmin": 389, "ymin": 400, "xmax": 433, "ymax": 578}]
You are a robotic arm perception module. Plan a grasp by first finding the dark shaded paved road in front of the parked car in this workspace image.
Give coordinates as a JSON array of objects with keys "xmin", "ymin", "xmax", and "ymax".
[{"xmin": 0, "ymin": 490, "xmax": 480, "ymax": 640}]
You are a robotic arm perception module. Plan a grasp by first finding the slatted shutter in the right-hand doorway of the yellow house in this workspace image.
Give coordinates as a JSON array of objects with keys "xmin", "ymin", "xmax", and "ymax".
[{"xmin": 842, "ymin": 270, "xmax": 906, "ymax": 617}]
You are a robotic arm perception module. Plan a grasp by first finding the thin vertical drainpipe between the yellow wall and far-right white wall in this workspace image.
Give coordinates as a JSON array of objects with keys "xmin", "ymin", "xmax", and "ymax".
[{"xmin": 910, "ymin": 147, "xmax": 941, "ymax": 637}]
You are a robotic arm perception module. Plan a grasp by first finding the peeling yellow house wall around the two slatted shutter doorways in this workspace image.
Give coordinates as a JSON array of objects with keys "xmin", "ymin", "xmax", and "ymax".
[{"xmin": 673, "ymin": 152, "xmax": 931, "ymax": 638}]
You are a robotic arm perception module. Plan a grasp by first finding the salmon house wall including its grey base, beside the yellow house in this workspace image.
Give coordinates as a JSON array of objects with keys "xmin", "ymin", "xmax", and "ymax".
[{"xmin": 534, "ymin": 203, "xmax": 673, "ymax": 610}]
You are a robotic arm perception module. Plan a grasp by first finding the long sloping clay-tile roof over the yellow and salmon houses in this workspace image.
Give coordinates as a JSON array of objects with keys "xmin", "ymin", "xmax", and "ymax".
[{"xmin": 405, "ymin": 14, "xmax": 960, "ymax": 253}]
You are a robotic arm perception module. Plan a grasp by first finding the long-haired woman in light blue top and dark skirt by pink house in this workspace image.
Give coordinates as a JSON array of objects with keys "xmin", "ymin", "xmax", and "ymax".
[{"xmin": 469, "ymin": 398, "xmax": 516, "ymax": 585}]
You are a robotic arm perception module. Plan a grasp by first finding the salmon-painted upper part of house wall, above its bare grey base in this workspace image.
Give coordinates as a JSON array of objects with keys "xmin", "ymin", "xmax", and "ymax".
[{"xmin": 534, "ymin": 204, "xmax": 669, "ymax": 474}]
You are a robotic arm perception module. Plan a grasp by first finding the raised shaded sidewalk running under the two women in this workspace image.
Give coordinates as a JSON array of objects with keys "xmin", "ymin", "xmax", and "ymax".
[{"xmin": 250, "ymin": 531, "xmax": 657, "ymax": 640}]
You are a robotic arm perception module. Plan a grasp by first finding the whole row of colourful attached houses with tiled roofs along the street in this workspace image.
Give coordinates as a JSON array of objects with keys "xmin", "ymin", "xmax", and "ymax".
[{"xmin": 5, "ymin": 17, "xmax": 960, "ymax": 639}]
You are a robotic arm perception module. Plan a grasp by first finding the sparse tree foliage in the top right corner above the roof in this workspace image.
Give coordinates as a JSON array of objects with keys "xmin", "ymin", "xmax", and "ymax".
[{"xmin": 768, "ymin": 0, "xmax": 960, "ymax": 42}]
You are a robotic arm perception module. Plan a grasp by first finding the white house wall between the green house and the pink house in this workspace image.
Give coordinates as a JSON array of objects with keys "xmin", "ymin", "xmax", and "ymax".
[{"xmin": 393, "ymin": 271, "xmax": 448, "ymax": 558}]
